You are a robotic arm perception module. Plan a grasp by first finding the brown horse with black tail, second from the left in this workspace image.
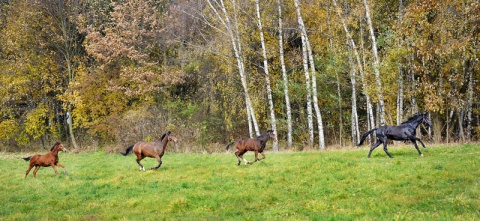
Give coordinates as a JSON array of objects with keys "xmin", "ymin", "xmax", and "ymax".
[{"xmin": 121, "ymin": 131, "xmax": 178, "ymax": 171}]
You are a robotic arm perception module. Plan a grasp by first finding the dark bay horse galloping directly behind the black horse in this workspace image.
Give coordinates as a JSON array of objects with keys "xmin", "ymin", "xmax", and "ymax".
[{"xmin": 225, "ymin": 130, "xmax": 277, "ymax": 166}]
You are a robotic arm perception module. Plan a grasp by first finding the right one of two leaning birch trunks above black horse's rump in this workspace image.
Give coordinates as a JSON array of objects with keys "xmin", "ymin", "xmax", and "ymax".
[{"xmin": 363, "ymin": 0, "xmax": 385, "ymax": 125}]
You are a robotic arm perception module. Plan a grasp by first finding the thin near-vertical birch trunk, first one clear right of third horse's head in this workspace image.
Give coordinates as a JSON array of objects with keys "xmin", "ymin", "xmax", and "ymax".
[{"xmin": 277, "ymin": 0, "xmax": 292, "ymax": 148}]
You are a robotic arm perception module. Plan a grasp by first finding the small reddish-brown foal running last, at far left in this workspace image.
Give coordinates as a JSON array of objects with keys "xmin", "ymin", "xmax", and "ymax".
[{"xmin": 23, "ymin": 142, "xmax": 68, "ymax": 178}]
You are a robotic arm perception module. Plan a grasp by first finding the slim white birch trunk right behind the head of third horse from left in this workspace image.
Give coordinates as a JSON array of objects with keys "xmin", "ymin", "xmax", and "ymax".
[{"xmin": 255, "ymin": 0, "xmax": 278, "ymax": 152}]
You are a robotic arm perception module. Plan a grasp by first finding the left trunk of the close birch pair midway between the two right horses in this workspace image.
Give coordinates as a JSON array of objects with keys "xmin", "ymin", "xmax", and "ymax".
[{"xmin": 293, "ymin": 0, "xmax": 315, "ymax": 147}]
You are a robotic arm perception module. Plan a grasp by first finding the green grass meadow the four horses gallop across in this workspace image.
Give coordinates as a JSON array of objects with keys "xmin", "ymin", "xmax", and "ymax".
[{"xmin": 0, "ymin": 144, "xmax": 480, "ymax": 221}]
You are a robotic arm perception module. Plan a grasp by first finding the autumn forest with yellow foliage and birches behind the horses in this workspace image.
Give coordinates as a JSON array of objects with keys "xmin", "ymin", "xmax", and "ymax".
[{"xmin": 0, "ymin": 0, "xmax": 480, "ymax": 151}]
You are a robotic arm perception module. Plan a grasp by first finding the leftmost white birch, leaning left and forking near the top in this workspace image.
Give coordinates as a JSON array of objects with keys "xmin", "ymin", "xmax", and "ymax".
[{"xmin": 206, "ymin": 0, "xmax": 260, "ymax": 137}]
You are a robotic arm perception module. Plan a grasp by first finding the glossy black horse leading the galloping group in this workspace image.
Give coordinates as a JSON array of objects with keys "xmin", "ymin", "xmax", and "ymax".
[{"xmin": 358, "ymin": 114, "xmax": 432, "ymax": 158}]
